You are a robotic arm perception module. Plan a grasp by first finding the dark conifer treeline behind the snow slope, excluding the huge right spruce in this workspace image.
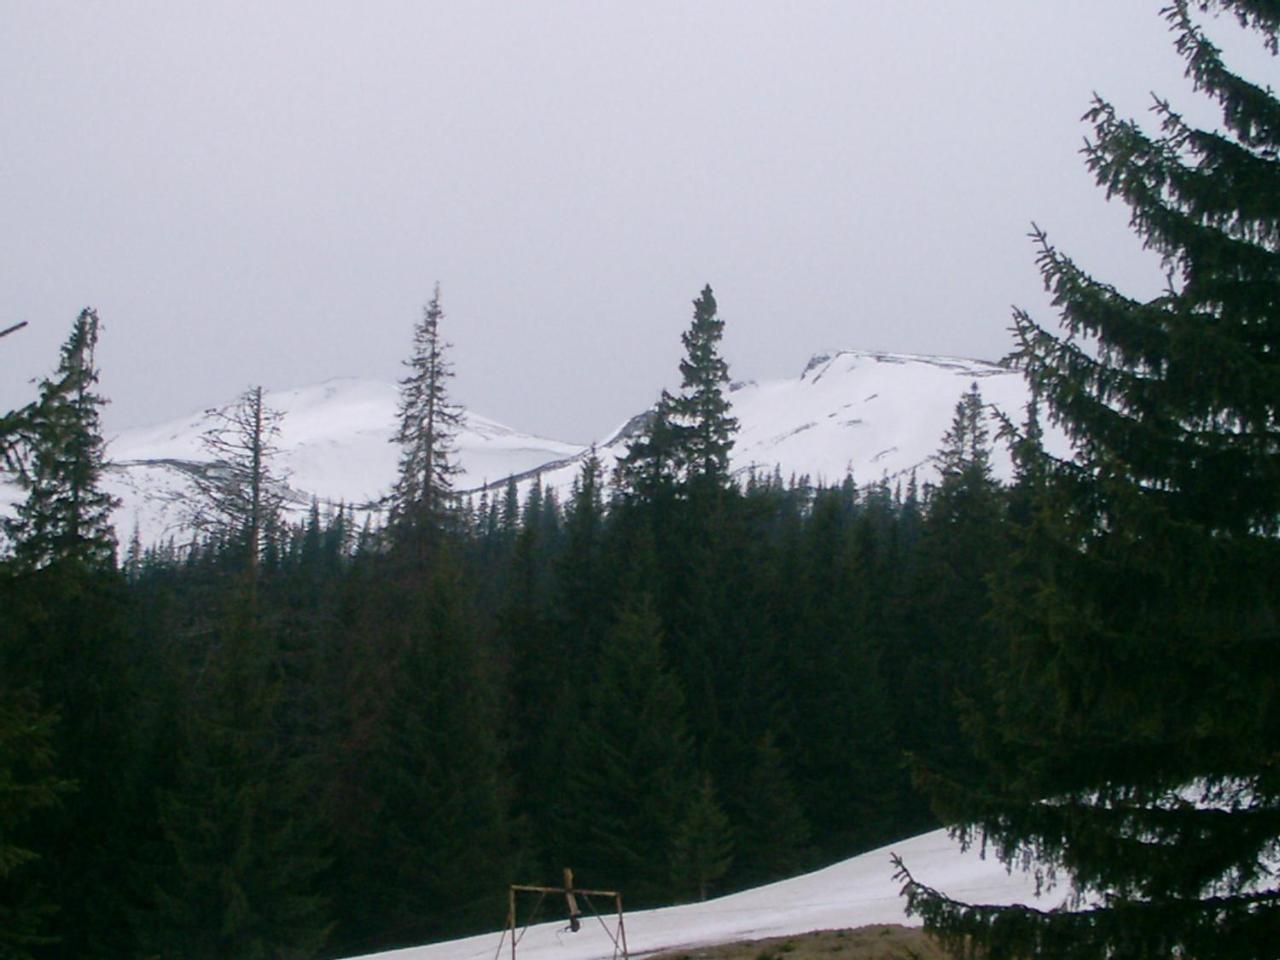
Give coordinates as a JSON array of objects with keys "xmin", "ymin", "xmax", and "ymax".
[{"xmin": 0, "ymin": 288, "xmax": 1009, "ymax": 957}]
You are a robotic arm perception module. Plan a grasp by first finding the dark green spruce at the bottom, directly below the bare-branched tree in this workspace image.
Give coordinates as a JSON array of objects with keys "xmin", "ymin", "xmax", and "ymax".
[{"xmin": 145, "ymin": 612, "xmax": 329, "ymax": 959}]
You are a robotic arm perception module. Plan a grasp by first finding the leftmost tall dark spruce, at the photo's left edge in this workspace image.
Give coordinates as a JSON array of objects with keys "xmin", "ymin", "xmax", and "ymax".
[{"xmin": 0, "ymin": 308, "xmax": 143, "ymax": 956}]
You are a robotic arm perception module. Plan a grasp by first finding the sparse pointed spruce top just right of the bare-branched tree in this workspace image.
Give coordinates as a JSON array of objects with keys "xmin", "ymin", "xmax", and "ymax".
[{"xmin": 390, "ymin": 284, "xmax": 462, "ymax": 549}]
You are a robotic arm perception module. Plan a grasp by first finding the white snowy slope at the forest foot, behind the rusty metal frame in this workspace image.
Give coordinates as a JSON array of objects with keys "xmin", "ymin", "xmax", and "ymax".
[{"xmin": 350, "ymin": 831, "xmax": 1065, "ymax": 960}]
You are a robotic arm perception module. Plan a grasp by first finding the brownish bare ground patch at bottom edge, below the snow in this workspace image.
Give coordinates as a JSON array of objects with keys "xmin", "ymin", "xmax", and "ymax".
[{"xmin": 646, "ymin": 923, "xmax": 952, "ymax": 960}]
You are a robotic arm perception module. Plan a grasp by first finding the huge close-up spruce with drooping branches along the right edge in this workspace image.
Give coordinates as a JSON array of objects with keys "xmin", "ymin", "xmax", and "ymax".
[{"xmin": 904, "ymin": 0, "xmax": 1280, "ymax": 960}]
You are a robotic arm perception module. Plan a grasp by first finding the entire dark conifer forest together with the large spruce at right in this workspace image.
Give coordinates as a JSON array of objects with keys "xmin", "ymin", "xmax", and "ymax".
[{"xmin": 0, "ymin": 0, "xmax": 1280, "ymax": 959}]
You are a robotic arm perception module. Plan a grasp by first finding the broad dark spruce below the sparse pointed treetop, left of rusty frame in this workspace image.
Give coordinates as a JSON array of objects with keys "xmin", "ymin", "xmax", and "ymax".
[{"xmin": 339, "ymin": 561, "xmax": 518, "ymax": 952}]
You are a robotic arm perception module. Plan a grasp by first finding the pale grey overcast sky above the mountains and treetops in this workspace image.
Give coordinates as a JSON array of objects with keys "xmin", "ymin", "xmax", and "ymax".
[{"xmin": 0, "ymin": 0, "xmax": 1277, "ymax": 440}]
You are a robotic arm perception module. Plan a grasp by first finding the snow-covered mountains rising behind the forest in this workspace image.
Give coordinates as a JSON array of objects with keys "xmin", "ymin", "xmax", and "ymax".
[{"xmin": 8, "ymin": 351, "xmax": 1062, "ymax": 543}]
